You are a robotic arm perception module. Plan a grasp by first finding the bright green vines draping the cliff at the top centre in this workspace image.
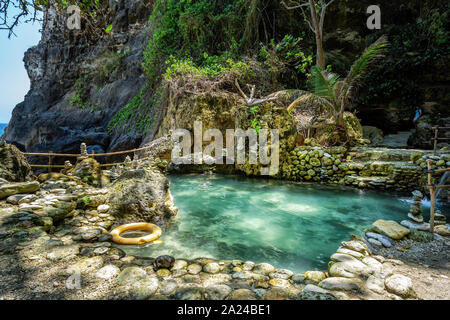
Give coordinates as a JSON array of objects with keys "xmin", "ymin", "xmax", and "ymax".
[{"xmin": 143, "ymin": 0, "xmax": 246, "ymax": 85}]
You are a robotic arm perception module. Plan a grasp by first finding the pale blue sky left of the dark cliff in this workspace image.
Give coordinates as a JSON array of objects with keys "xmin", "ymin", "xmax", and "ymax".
[{"xmin": 0, "ymin": 9, "xmax": 41, "ymax": 123}]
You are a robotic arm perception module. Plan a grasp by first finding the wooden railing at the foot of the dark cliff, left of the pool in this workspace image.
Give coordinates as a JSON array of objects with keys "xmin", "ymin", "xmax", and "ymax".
[{"xmin": 22, "ymin": 146, "xmax": 156, "ymax": 173}]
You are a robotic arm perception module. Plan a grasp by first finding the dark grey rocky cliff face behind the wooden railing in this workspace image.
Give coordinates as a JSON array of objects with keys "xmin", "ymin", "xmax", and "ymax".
[{"xmin": 5, "ymin": 0, "xmax": 155, "ymax": 158}]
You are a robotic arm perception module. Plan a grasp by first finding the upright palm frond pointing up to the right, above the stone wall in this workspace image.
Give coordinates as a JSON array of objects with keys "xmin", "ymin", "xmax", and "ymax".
[{"xmin": 344, "ymin": 36, "xmax": 389, "ymax": 96}]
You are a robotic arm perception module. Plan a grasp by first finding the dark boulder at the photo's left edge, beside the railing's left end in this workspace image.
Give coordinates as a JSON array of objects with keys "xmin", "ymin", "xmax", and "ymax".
[{"xmin": 0, "ymin": 142, "xmax": 33, "ymax": 182}]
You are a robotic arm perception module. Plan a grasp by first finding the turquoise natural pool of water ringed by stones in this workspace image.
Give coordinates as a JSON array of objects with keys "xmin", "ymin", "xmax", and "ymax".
[{"xmin": 120, "ymin": 175, "xmax": 448, "ymax": 272}]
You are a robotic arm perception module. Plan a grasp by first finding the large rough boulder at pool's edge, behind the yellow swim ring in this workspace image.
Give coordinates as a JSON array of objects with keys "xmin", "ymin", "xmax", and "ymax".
[{"xmin": 107, "ymin": 168, "xmax": 177, "ymax": 226}]
